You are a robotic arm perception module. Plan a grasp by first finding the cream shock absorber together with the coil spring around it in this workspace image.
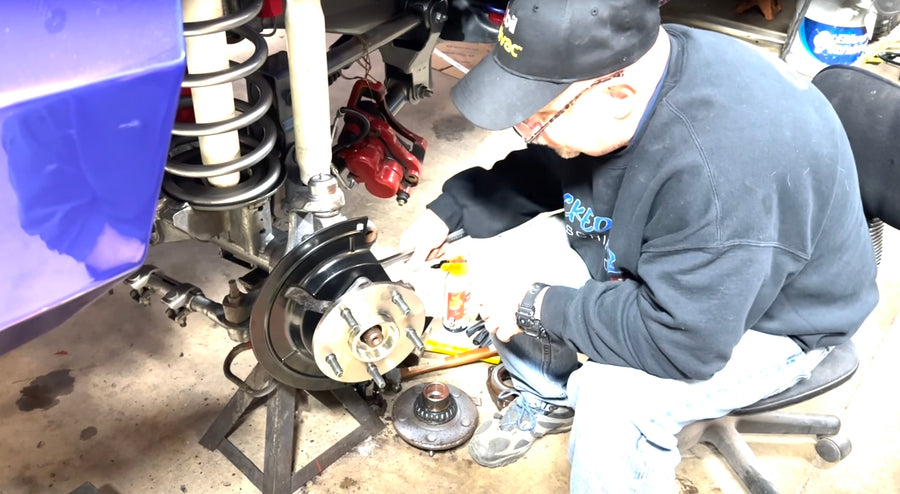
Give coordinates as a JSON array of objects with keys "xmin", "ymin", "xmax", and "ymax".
[{"xmin": 163, "ymin": 0, "xmax": 284, "ymax": 210}]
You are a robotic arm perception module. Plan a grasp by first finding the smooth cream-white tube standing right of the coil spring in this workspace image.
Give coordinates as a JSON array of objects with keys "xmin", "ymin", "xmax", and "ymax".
[{"xmin": 284, "ymin": 0, "xmax": 331, "ymax": 184}]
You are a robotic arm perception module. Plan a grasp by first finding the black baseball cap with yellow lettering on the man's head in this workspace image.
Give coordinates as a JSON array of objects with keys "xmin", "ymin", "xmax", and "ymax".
[{"xmin": 450, "ymin": 0, "xmax": 660, "ymax": 130}]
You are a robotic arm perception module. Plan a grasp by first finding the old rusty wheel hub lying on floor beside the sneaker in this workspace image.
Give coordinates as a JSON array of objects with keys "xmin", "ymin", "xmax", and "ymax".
[{"xmin": 391, "ymin": 382, "xmax": 478, "ymax": 451}]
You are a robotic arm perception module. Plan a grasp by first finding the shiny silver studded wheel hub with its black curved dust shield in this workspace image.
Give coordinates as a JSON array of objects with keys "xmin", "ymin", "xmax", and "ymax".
[{"xmin": 250, "ymin": 218, "xmax": 425, "ymax": 391}]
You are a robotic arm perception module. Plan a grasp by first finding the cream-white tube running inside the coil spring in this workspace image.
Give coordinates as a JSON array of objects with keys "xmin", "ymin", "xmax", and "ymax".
[{"xmin": 182, "ymin": 0, "xmax": 241, "ymax": 187}]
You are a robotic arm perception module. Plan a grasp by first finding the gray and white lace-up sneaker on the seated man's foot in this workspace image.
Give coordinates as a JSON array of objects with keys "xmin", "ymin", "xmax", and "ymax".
[{"xmin": 469, "ymin": 396, "xmax": 575, "ymax": 468}]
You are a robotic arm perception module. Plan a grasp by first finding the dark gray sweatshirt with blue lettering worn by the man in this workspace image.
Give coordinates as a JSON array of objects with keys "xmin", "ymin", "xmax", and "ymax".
[{"xmin": 429, "ymin": 26, "xmax": 878, "ymax": 380}]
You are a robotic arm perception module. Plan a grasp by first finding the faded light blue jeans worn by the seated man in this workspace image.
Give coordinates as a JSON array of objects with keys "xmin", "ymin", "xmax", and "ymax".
[{"xmin": 494, "ymin": 330, "xmax": 827, "ymax": 494}]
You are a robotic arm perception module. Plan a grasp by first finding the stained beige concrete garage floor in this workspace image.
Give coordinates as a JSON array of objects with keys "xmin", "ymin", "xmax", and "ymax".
[{"xmin": 0, "ymin": 23, "xmax": 900, "ymax": 494}]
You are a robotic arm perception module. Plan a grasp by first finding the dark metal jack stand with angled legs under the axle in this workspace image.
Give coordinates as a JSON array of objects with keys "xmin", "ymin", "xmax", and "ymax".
[{"xmin": 200, "ymin": 365, "xmax": 384, "ymax": 494}]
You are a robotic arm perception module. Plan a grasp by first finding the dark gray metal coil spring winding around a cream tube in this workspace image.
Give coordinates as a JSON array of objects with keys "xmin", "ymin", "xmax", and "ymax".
[{"xmin": 163, "ymin": 0, "xmax": 284, "ymax": 210}]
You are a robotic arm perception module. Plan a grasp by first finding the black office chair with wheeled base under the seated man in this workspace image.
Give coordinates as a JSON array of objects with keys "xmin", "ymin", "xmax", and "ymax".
[{"xmin": 678, "ymin": 66, "xmax": 900, "ymax": 494}]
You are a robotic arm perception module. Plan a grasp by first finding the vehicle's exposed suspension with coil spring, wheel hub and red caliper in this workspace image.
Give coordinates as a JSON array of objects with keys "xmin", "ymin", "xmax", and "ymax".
[{"xmin": 133, "ymin": 0, "xmax": 503, "ymax": 390}]
